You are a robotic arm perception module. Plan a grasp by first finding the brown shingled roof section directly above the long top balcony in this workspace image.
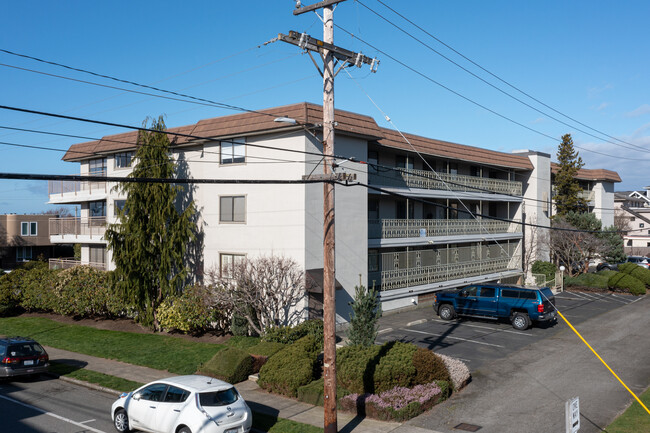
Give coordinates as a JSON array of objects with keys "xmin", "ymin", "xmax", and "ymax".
[{"xmin": 379, "ymin": 128, "xmax": 534, "ymax": 170}]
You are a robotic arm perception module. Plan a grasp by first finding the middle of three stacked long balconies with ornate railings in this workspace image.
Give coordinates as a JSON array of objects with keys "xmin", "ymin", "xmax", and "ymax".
[{"xmin": 368, "ymin": 219, "xmax": 521, "ymax": 239}]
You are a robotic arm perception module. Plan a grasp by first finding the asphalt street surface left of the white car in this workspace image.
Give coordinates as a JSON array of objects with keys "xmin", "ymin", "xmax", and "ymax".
[{"xmin": 0, "ymin": 376, "xmax": 116, "ymax": 433}]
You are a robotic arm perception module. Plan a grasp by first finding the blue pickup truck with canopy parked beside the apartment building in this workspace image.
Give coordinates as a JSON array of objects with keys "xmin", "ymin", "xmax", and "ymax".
[{"xmin": 433, "ymin": 284, "xmax": 557, "ymax": 330}]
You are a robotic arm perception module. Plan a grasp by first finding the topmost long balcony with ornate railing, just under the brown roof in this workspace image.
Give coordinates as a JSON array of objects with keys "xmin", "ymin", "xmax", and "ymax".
[{"xmin": 369, "ymin": 168, "xmax": 522, "ymax": 196}]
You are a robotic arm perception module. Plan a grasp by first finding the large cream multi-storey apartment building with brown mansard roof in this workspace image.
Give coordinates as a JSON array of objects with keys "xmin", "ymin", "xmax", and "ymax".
[{"xmin": 50, "ymin": 103, "xmax": 613, "ymax": 322}]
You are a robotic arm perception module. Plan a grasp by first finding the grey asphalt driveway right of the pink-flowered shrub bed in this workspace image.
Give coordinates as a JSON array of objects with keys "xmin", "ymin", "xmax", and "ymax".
[{"xmin": 403, "ymin": 294, "xmax": 650, "ymax": 433}]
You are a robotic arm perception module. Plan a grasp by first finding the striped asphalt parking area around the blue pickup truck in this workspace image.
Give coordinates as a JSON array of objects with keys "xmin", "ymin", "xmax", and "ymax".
[{"xmin": 377, "ymin": 292, "xmax": 640, "ymax": 371}]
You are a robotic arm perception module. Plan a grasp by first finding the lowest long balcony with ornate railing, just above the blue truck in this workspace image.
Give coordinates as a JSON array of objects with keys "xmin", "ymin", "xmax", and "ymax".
[{"xmin": 368, "ymin": 243, "xmax": 517, "ymax": 291}]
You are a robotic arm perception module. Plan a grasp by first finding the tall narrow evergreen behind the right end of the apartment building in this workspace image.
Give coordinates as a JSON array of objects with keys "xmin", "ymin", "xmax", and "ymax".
[{"xmin": 554, "ymin": 134, "xmax": 588, "ymax": 216}]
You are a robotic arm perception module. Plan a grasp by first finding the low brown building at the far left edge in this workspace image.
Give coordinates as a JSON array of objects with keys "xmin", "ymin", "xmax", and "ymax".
[{"xmin": 0, "ymin": 214, "xmax": 56, "ymax": 269}]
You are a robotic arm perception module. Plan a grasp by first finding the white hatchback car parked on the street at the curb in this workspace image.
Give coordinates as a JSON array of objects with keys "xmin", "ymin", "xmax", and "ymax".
[{"xmin": 111, "ymin": 375, "xmax": 253, "ymax": 433}]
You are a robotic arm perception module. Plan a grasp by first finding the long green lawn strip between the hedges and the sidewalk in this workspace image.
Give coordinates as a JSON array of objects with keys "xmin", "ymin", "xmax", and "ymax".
[{"xmin": 0, "ymin": 317, "xmax": 224, "ymax": 374}]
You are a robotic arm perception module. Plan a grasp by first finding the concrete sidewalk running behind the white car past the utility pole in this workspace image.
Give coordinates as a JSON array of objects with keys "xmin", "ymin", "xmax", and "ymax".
[{"xmin": 45, "ymin": 347, "xmax": 435, "ymax": 433}]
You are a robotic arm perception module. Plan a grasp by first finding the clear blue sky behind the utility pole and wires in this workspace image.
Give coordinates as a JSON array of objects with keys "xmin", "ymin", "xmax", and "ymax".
[{"xmin": 0, "ymin": 0, "xmax": 650, "ymax": 213}]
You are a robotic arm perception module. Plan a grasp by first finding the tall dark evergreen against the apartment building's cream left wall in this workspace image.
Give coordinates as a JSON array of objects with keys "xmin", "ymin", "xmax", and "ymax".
[{"xmin": 105, "ymin": 116, "xmax": 196, "ymax": 329}]
